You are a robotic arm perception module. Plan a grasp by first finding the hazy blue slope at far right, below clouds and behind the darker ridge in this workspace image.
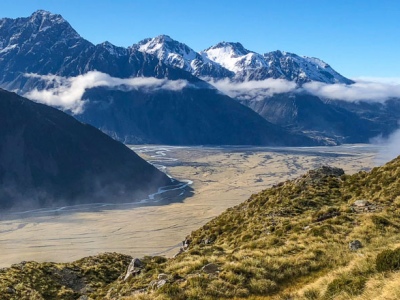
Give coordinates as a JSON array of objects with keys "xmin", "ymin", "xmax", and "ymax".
[{"xmin": 240, "ymin": 93, "xmax": 388, "ymax": 144}]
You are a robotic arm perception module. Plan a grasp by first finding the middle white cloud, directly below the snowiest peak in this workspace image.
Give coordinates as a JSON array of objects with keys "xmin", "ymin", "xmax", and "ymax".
[{"xmin": 206, "ymin": 78, "xmax": 296, "ymax": 100}]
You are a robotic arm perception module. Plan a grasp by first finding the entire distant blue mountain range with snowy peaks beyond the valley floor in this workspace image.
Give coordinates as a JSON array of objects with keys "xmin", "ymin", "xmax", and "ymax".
[{"xmin": 0, "ymin": 11, "xmax": 399, "ymax": 146}]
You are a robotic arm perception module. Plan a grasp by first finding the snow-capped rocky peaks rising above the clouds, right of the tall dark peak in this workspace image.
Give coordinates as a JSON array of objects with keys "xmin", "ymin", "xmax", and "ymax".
[{"xmin": 132, "ymin": 35, "xmax": 353, "ymax": 85}]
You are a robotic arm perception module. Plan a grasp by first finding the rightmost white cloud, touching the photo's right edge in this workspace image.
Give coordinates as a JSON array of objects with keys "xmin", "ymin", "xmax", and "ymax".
[{"xmin": 303, "ymin": 78, "xmax": 400, "ymax": 102}]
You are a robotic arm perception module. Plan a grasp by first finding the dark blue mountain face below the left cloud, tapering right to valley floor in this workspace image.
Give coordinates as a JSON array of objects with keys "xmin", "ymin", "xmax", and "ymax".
[{"xmin": 76, "ymin": 88, "xmax": 317, "ymax": 146}]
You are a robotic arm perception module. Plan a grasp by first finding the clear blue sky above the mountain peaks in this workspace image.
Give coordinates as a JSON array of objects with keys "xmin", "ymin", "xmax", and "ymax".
[{"xmin": 0, "ymin": 0, "xmax": 400, "ymax": 78}]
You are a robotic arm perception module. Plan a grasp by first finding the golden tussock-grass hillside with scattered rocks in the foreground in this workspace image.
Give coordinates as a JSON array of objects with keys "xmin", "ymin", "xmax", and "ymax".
[{"xmin": 0, "ymin": 157, "xmax": 400, "ymax": 299}]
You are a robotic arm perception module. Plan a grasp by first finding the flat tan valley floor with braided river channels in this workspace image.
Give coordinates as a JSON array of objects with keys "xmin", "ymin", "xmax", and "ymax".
[{"xmin": 0, "ymin": 146, "xmax": 379, "ymax": 267}]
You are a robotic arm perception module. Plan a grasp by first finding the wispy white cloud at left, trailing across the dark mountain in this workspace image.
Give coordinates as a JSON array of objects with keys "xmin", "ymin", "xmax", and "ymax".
[{"xmin": 24, "ymin": 71, "xmax": 189, "ymax": 114}]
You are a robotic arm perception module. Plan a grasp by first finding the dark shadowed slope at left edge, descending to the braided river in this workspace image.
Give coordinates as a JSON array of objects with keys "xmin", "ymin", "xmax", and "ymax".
[{"xmin": 0, "ymin": 90, "xmax": 171, "ymax": 209}]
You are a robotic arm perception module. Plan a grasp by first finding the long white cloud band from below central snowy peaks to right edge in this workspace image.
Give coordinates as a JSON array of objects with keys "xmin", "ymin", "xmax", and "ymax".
[{"xmin": 207, "ymin": 77, "xmax": 400, "ymax": 102}]
